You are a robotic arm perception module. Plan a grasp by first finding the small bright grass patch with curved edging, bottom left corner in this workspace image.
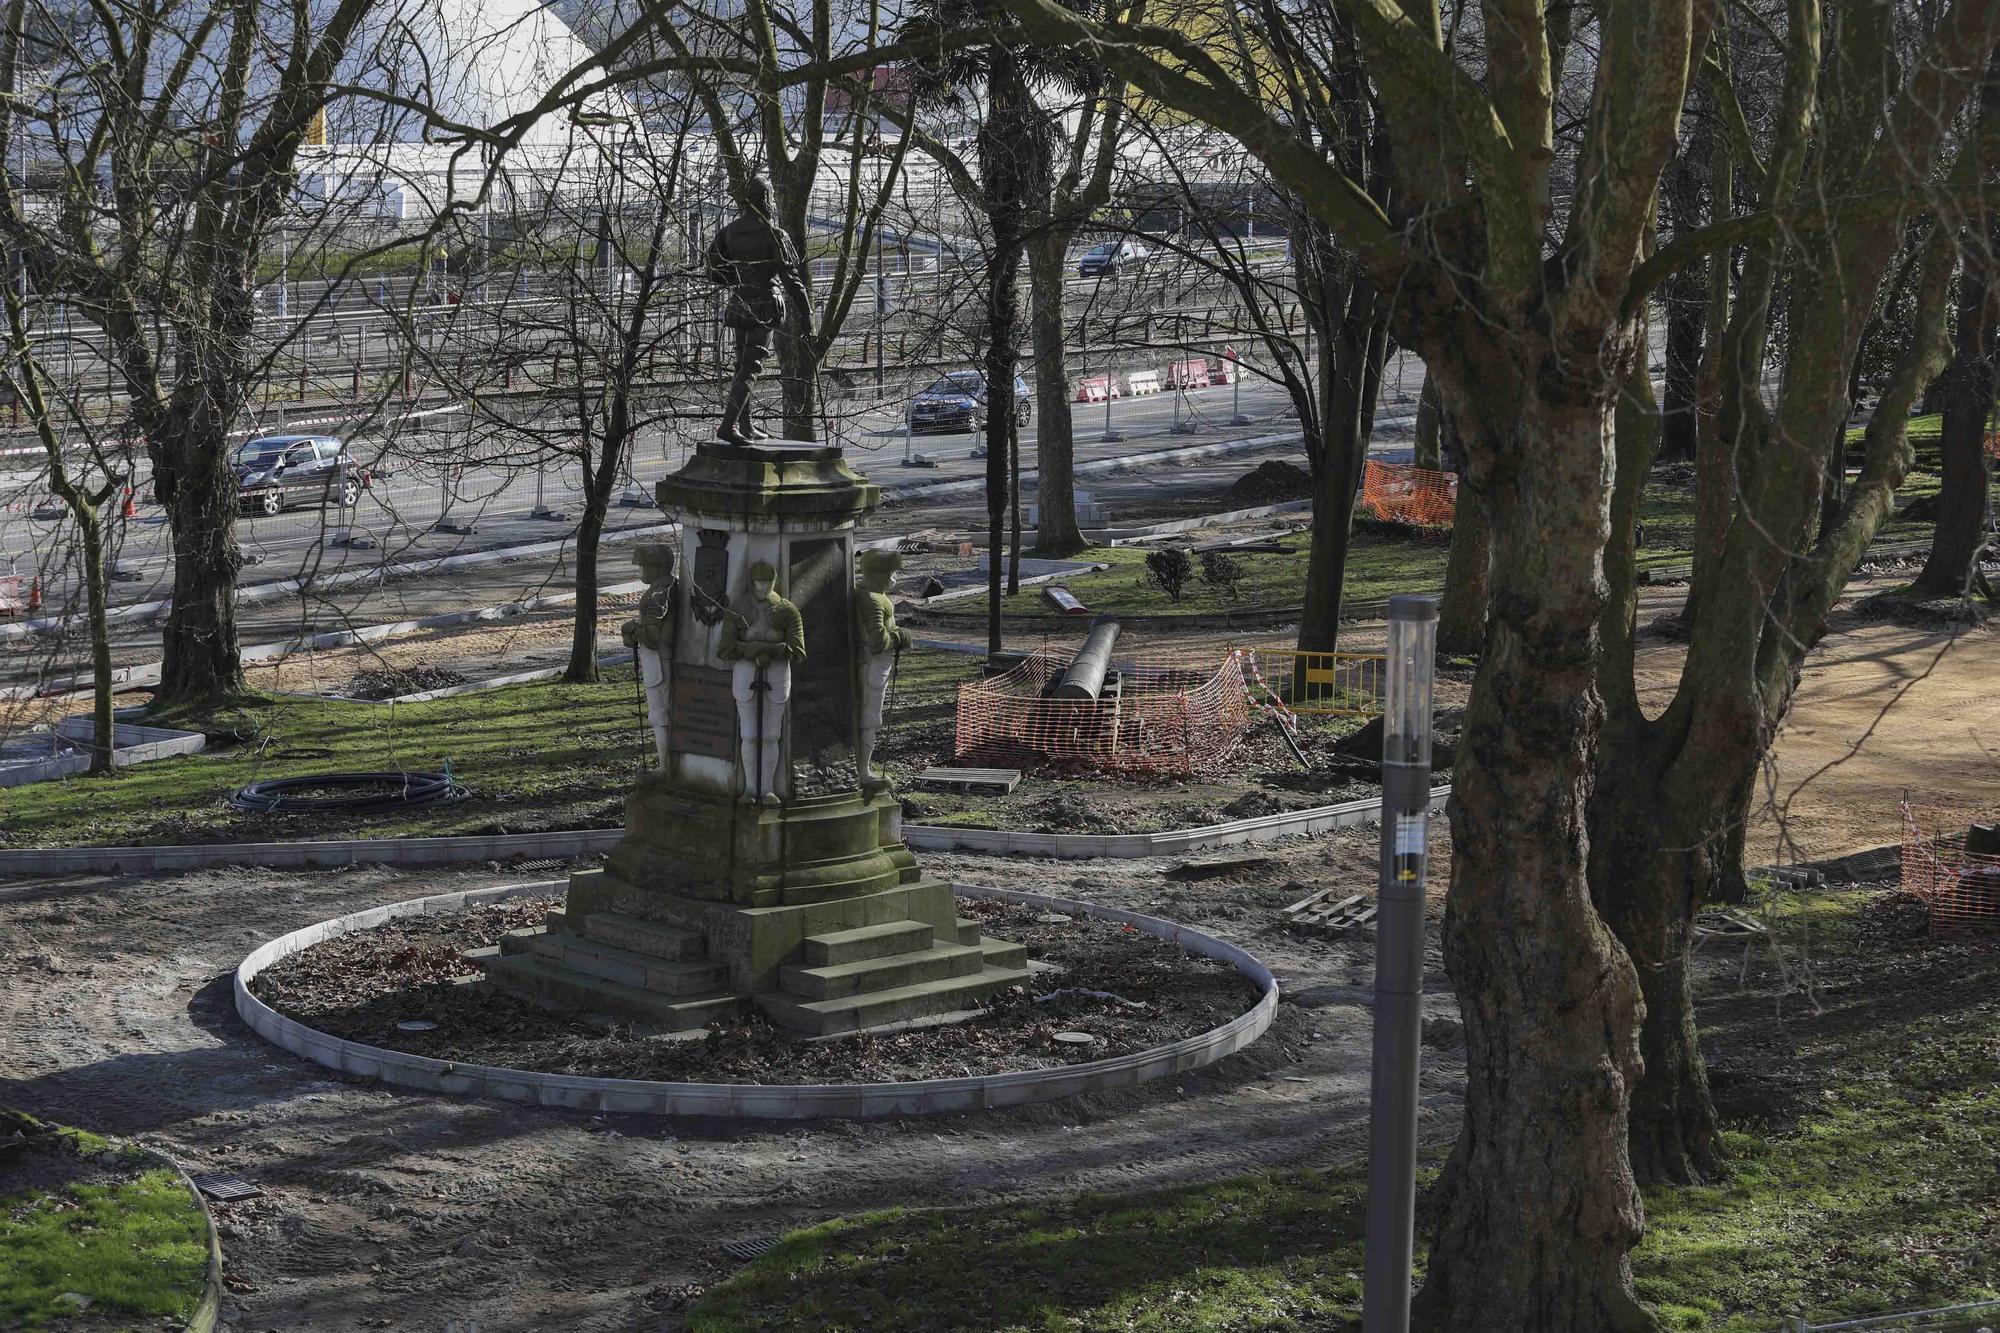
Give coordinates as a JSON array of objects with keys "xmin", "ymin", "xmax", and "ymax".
[{"xmin": 0, "ymin": 1112, "xmax": 208, "ymax": 1329}]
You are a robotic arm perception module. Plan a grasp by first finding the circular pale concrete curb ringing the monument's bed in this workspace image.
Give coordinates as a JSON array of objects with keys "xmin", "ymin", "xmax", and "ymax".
[{"xmin": 232, "ymin": 881, "xmax": 1278, "ymax": 1121}]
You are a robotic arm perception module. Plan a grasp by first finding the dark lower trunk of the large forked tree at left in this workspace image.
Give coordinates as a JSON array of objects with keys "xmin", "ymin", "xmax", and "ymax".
[{"xmin": 154, "ymin": 416, "xmax": 246, "ymax": 707}]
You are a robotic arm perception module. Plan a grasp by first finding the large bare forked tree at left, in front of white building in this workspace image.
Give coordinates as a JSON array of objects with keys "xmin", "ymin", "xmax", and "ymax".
[{"xmin": 0, "ymin": 0, "xmax": 394, "ymax": 705}]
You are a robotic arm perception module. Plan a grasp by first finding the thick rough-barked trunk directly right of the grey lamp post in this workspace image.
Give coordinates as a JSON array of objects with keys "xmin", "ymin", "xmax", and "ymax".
[{"xmin": 1418, "ymin": 384, "xmax": 1656, "ymax": 1333}]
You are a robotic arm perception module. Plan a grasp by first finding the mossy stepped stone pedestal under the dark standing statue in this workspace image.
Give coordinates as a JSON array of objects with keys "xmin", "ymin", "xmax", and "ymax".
[{"xmin": 472, "ymin": 440, "xmax": 1028, "ymax": 1033}]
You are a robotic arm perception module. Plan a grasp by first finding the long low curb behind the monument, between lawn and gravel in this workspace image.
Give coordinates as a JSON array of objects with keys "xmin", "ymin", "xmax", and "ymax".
[{"xmin": 0, "ymin": 787, "xmax": 1452, "ymax": 879}]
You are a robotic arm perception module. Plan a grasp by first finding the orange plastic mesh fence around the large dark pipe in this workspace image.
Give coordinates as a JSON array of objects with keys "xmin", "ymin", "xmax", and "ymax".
[{"xmin": 956, "ymin": 648, "xmax": 1252, "ymax": 773}]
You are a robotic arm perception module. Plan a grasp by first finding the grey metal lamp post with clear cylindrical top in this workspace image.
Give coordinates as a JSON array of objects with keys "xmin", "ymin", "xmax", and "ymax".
[{"xmin": 1362, "ymin": 594, "xmax": 1438, "ymax": 1333}]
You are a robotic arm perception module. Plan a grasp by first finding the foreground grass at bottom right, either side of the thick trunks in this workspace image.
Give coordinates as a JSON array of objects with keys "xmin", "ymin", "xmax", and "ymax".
[{"xmin": 692, "ymin": 895, "xmax": 2000, "ymax": 1333}]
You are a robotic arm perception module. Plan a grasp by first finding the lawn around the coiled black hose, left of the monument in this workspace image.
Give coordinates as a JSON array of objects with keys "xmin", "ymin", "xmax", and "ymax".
[{"xmin": 0, "ymin": 667, "xmax": 650, "ymax": 847}]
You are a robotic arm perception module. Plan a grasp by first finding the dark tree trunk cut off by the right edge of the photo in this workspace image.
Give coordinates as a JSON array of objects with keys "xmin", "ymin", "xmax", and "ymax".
[{"xmin": 1916, "ymin": 226, "xmax": 2000, "ymax": 596}]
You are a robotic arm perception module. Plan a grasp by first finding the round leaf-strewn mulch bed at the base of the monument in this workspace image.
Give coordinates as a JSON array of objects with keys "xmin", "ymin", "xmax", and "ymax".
[{"xmin": 250, "ymin": 899, "xmax": 1256, "ymax": 1083}]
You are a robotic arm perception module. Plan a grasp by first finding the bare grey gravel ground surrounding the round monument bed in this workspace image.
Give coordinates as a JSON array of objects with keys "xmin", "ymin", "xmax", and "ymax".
[{"xmin": 0, "ymin": 831, "xmax": 1464, "ymax": 1333}]
